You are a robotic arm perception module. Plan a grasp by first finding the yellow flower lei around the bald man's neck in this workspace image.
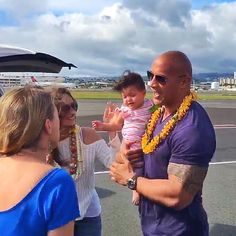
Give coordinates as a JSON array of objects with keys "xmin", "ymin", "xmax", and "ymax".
[{"xmin": 142, "ymin": 92, "xmax": 197, "ymax": 154}]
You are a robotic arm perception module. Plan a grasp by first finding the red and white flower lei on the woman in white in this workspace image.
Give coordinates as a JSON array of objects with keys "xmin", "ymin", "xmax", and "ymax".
[{"xmin": 69, "ymin": 126, "xmax": 84, "ymax": 179}]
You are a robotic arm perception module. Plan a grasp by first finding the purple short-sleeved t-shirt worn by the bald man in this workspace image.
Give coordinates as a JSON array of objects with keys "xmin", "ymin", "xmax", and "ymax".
[{"xmin": 139, "ymin": 102, "xmax": 216, "ymax": 236}]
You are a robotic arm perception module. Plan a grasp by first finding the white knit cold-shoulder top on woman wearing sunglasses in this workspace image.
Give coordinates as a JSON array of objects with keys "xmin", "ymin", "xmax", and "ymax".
[{"xmin": 58, "ymin": 129, "xmax": 120, "ymax": 220}]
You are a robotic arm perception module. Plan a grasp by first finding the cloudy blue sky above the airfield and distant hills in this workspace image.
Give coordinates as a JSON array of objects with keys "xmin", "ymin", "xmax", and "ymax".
[{"xmin": 0, "ymin": 0, "xmax": 236, "ymax": 76}]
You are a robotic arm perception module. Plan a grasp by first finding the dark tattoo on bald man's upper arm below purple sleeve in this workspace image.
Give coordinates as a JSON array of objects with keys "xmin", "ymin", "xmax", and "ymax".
[{"xmin": 168, "ymin": 163, "xmax": 208, "ymax": 196}]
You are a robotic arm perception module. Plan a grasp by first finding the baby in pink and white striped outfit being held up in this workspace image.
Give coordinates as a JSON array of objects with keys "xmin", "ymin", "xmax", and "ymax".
[{"xmin": 92, "ymin": 71, "xmax": 153, "ymax": 205}]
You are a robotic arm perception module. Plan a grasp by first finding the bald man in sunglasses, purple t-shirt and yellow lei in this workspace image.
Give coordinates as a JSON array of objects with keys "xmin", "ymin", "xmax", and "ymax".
[{"xmin": 110, "ymin": 51, "xmax": 216, "ymax": 236}]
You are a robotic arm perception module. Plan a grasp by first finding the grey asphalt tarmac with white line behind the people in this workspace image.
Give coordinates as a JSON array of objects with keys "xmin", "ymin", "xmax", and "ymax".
[{"xmin": 78, "ymin": 100, "xmax": 236, "ymax": 236}]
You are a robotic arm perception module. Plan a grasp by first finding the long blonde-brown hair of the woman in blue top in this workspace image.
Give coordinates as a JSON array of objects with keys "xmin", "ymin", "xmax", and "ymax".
[{"xmin": 0, "ymin": 86, "xmax": 54, "ymax": 155}]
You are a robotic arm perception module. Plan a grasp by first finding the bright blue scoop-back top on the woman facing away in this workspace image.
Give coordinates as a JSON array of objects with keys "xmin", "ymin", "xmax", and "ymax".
[{"xmin": 0, "ymin": 168, "xmax": 80, "ymax": 236}]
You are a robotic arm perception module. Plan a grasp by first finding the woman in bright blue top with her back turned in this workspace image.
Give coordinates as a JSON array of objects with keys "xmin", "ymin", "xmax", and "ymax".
[{"xmin": 0, "ymin": 87, "xmax": 79, "ymax": 236}]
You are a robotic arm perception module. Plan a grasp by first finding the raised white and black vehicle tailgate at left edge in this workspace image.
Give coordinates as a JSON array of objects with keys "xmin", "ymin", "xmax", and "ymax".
[{"xmin": 0, "ymin": 45, "xmax": 76, "ymax": 73}]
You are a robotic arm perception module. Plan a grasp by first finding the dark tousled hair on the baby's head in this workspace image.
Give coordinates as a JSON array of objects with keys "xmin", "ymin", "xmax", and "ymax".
[{"xmin": 113, "ymin": 70, "xmax": 146, "ymax": 92}]
